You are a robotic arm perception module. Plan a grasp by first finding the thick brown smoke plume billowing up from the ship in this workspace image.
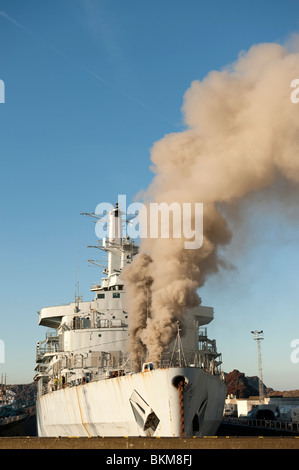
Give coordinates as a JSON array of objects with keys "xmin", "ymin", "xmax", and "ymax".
[{"xmin": 122, "ymin": 40, "xmax": 299, "ymax": 370}]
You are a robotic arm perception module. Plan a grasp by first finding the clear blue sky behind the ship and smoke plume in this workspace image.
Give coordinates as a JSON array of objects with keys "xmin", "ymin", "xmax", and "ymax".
[{"xmin": 0, "ymin": 0, "xmax": 299, "ymax": 390}]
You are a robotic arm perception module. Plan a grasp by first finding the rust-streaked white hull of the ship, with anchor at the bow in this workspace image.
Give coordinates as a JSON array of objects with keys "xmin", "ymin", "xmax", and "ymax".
[{"xmin": 37, "ymin": 367, "xmax": 226, "ymax": 437}]
